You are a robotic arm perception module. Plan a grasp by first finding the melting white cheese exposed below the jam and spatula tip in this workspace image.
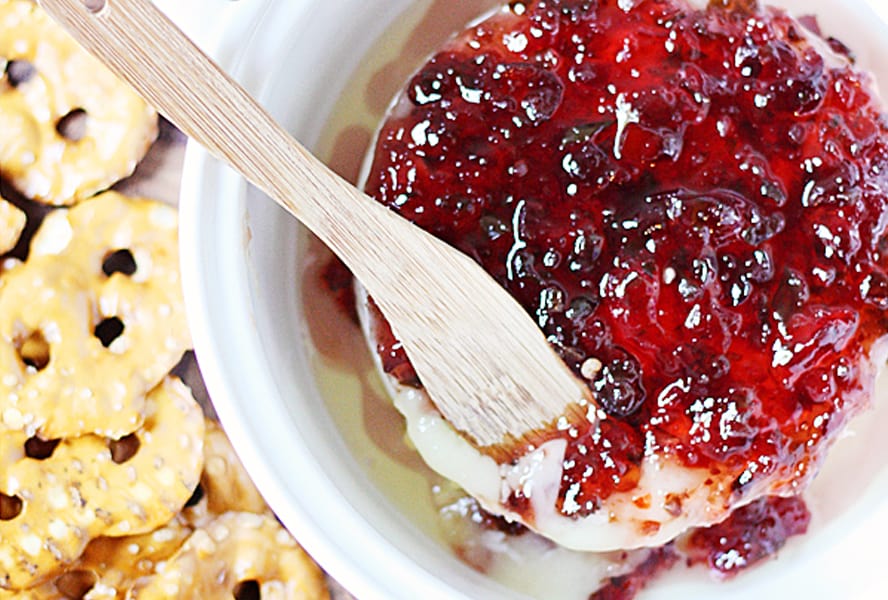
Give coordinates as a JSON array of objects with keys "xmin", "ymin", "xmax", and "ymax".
[{"xmin": 357, "ymin": 288, "xmax": 888, "ymax": 552}]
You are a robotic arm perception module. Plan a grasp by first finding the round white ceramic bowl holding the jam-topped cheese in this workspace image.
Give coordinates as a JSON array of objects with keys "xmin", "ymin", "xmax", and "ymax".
[{"xmin": 177, "ymin": 0, "xmax": 888, "ymax": 600}]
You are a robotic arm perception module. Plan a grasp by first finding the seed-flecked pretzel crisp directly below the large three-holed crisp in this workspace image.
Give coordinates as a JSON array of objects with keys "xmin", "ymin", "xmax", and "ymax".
[{"xmin": 0, "ymin": 377, "xmax": 204, "ymax": 589}]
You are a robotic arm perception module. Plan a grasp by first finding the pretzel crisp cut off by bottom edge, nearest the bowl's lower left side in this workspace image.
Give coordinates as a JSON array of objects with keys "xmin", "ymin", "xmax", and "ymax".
[{"xmin": 129, "ymin": 512, "xmax": 329, "ymax": 600}]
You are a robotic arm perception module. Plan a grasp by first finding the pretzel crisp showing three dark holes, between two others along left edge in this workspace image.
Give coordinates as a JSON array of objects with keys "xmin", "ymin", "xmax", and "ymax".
[{"xmin": 0, "ymin": 192, "xmax": 190, "ymax": 439}]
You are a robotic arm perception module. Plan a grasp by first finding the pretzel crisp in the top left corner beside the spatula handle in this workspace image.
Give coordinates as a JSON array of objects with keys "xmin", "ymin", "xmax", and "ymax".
[{"xmin": 0, "ymin": 0, "xmax": 157, "ymax": 206}]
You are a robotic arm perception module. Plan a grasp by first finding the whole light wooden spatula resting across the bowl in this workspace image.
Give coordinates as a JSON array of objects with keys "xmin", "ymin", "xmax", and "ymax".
[{"xmin": 39, "ymin": 0, "xmax": 589, "ymax": 451}]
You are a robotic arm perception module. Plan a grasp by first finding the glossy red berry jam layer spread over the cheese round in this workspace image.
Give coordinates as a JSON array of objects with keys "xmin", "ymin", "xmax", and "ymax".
[{"xmin": 366, "ymin": 0, "xmax": 888, "ymax": 522}]
